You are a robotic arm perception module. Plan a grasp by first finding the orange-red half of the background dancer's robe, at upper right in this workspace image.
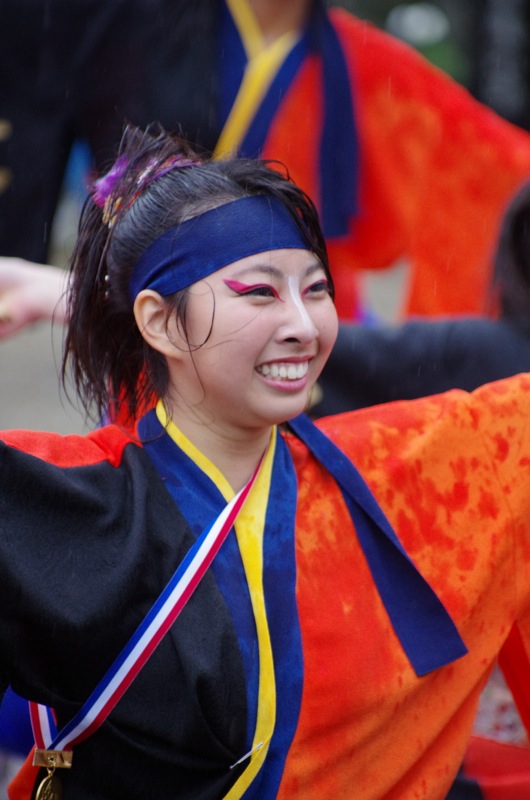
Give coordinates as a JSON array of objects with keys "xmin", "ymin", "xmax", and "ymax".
[{"xmin": 264, "ymin": 8, "xmax": 530, "ymax": 318}]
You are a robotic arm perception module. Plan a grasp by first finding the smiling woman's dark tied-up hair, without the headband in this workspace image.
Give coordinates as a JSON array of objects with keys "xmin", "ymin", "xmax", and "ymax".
[{"xmin": 62, "ymin": 125, "xmax": 333, "ymax": 423}]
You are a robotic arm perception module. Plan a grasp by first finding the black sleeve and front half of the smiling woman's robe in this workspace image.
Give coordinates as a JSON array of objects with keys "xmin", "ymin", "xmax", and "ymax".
[{"xmin": 0, "ymin": 443, "xmax": 247, "ymax": 800}]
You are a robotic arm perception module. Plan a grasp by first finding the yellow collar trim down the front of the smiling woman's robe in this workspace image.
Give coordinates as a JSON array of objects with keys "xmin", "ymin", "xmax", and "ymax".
[{"xmin": 156, "ymin": 401, "xmax": 276, "ymax": 800}]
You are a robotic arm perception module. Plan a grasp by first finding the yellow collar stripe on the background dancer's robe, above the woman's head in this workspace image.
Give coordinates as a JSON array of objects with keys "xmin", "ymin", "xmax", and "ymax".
[{"xmin": 214, "ymin": 0, "xmax": 300, "ymax": 158}]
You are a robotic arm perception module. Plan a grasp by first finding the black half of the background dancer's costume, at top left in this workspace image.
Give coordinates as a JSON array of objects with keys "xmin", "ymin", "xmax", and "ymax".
[{"xmin": 0, "ymin": 0, "xmax": 216, "ymax": 262}]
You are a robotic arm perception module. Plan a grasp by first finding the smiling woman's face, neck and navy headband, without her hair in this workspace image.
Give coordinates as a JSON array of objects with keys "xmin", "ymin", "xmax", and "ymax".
[{"xmin": 126, "ymin": 203, "xmax": 337, "ymax": 489}]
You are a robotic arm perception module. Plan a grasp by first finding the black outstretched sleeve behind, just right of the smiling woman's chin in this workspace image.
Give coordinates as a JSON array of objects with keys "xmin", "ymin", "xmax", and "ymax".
[{"xmin": 312, "ymin": 318, "xmax": 530, "ymax": 416}]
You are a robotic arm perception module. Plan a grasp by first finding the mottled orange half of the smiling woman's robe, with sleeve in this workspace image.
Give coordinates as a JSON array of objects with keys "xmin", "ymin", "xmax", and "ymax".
[{"xmin": 278, "ymin": 376, "xmax": 530, "ymax": 800}]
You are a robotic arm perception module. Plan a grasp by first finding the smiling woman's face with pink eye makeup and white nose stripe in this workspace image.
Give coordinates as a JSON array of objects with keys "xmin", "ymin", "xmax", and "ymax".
[{"xmin": 165, "ymin": 249, "xmax": 338, "ymax": 429}]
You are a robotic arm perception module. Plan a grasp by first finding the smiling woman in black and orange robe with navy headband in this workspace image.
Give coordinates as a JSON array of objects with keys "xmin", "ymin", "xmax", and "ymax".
[{"xmin": 4, "ymin": 129, "xmax": 530, "ymax": 800}]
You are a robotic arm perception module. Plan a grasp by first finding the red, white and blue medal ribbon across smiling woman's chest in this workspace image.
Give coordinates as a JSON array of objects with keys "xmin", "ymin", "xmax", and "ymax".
[{"xmin": 29, "ymin": 454, "xmax": 261, "ymax": 750}]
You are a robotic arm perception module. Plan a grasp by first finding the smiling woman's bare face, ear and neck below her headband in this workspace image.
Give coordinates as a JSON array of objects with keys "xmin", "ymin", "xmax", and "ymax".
[{"xmin": 135, "ymin": 245, "xmax": 337, "ymax": 489}]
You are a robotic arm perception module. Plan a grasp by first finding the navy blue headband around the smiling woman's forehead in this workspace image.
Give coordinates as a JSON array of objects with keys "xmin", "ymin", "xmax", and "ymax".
[{"xmin": 130, "ymin": 195, "xmax": 309, "ymax": 300}]
